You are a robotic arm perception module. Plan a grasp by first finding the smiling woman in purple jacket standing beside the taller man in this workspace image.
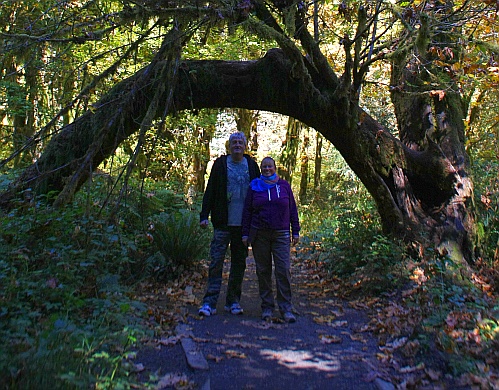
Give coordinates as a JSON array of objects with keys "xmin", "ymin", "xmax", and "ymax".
[{"xmin": 242, "ymin": 157, "xmax": 300, "ymax": 322}]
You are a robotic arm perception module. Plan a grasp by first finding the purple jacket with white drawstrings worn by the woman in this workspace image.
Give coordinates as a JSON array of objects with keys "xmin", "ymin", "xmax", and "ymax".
[{"xmin": 242, "ymin": 179, "xmax": 300, "ymax": 236}]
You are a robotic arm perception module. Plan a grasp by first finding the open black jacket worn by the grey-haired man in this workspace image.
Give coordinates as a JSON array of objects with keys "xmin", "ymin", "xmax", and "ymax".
[{"xmin": 199, "ymin": 154, "xmax": 260, "ymax": 229}]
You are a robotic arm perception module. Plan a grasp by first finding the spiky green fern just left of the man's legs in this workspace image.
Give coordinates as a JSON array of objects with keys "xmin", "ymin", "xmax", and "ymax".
[{"xmin": 151, "ymin": 212, "xmax": 210, "ymax": 280}]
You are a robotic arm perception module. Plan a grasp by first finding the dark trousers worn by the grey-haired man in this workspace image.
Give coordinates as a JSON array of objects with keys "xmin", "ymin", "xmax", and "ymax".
[{"xmin": 203, "ymin": 226, "xmax": 248, "ymax": 309}]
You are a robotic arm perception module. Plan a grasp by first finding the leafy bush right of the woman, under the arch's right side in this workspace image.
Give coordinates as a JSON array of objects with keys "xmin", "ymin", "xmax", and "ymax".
[{"xmin": 301, "ymin": 194, "xmax": 408, "ymax": 293}]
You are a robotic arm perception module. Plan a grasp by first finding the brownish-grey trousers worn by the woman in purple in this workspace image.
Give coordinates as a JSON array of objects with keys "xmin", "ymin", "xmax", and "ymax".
[{"xmin": 251, "ymin": 230, "xmax": 293, "ymax": 313}]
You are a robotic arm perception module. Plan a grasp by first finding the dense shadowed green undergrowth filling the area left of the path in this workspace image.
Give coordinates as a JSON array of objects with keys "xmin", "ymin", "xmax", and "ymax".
[{"xmin": 0, "ymin": 176, "xmax": 204, "ymax": 389}]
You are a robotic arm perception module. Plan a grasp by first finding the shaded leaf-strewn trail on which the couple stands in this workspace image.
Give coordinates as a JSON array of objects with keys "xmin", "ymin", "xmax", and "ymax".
[{"xmin": 137, "ymin": 257, "xmax": 393, "ymax": 390}]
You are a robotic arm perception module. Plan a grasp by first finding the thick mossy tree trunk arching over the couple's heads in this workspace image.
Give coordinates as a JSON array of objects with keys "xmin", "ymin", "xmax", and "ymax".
[{"xmin": 0, "ymin": 49, "xmax": 471, "ymax": 262}]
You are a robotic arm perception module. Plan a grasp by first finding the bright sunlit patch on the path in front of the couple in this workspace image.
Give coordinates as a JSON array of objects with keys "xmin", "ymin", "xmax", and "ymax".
[{"xmin": 260, "ymin": 349, "xmax": 341, "ymax": 372}]
